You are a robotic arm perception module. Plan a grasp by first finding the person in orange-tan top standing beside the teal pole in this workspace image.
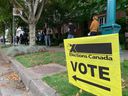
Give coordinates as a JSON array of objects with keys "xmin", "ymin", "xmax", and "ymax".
[{"xmin": 89, "ymin": 15, "xmax": 99, "ymax": 36}]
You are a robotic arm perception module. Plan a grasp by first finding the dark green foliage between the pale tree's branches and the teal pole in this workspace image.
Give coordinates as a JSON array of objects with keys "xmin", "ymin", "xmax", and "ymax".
[{"xmin": 40, "ymin": 0, "xmax": 106, "ymax": 24}]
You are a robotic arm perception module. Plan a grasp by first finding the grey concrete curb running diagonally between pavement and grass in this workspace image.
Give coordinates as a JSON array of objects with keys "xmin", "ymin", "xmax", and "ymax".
[{"xmin": 7, "ymin": 56, "xmax": 59, "ymax": 96}]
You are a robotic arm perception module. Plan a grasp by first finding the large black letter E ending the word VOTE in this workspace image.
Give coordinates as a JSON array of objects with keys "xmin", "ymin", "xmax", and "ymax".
[{"xmin": 99, "ymin": 66, "xmax": 110, "ymax": 81}]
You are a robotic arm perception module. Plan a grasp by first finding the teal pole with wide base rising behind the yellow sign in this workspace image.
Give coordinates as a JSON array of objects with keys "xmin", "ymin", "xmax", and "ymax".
[{"xmin": 101, "ymin": 0, "xmax": 121, "ymax": 35}]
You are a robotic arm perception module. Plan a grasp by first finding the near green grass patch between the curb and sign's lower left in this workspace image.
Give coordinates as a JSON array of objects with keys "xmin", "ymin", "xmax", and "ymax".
[{"xmin": 43, "ymin": 73, "xmax": 94, "ymax": 96}]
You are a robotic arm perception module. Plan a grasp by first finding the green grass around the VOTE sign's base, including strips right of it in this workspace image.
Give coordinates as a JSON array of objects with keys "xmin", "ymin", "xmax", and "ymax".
[{"xmin": 42, "ymin": 61, "xmax": 128, "ymax": 96}]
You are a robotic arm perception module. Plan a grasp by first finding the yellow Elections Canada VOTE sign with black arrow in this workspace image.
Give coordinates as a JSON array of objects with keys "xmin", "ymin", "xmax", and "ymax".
[{"xmin": 64, "ymin": 34, "xmax": 122, "ymax": 96}]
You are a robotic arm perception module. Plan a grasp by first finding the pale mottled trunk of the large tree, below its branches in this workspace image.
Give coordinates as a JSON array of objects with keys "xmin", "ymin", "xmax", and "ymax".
[{"xmin": 29, "ymin": 23, "xmax": 36, "ymax": 46}]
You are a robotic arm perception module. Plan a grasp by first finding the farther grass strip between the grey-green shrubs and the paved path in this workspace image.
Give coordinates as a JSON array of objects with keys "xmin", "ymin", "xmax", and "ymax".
[{"xmin": 16, "ymin": 52, "xmax": 66, "ymax": 68}]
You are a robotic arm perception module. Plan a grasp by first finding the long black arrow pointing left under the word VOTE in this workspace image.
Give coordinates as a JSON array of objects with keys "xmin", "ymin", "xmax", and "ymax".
[{"xmin": 72, "ymin": 75, "xmax": 111, "ymax": 91}]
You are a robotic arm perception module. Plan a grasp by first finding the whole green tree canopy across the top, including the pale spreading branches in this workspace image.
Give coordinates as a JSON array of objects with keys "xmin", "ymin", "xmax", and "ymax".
[{"xmin": 0, "ymin": 0, "xmax": 128, "ymax": 42}]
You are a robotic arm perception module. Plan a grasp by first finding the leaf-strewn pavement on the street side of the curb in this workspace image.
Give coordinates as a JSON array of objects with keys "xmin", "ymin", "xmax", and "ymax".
[{"xmin": 0, "ymin": 52, "xmax": 32, "ymax": 96}]
